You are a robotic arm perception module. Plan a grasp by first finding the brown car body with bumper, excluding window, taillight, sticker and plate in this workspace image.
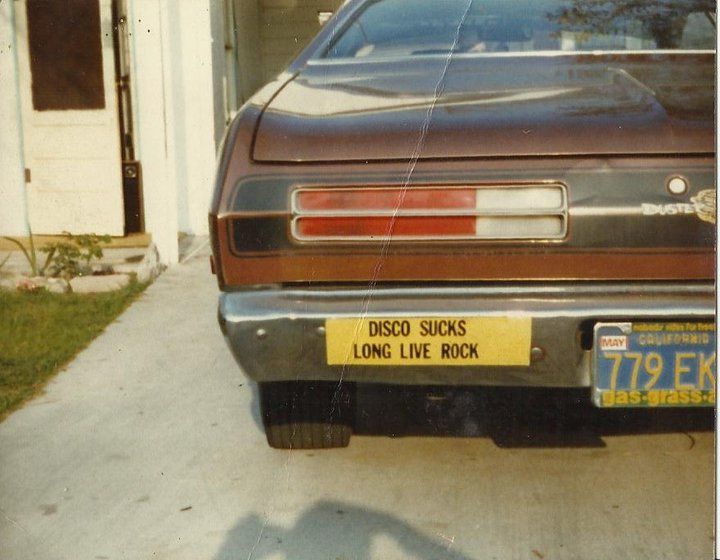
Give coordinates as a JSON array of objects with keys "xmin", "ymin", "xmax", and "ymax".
[{"xmin": 210, "ymin": 0, "xmax": 716, "ymax": 396}]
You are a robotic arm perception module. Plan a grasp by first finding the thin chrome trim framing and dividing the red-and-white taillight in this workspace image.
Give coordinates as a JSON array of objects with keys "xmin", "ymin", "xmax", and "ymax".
[{"xmin": 290, "ymin": 182, "xmax": 569, "ymax": 243}]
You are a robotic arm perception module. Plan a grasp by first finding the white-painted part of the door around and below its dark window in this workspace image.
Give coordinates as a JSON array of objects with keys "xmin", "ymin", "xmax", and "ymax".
[{"xmin": 14, "ymin": 0, "xmax": 123, "ymax": 236}]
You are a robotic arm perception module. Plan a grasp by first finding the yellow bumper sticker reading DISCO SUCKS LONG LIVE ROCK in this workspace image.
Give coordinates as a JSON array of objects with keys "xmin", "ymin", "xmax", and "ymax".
[{"xmin": 325, "ymin": 317, "xmax": 532, "ymax": 366}]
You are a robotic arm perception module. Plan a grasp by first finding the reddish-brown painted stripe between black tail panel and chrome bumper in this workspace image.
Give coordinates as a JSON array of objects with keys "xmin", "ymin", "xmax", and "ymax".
[{"xmin": 222, "ymin": 244, "xmax": 715, "ymax": 286}]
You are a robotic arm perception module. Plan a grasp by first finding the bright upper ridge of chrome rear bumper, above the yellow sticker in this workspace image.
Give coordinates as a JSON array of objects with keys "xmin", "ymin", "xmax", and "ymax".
[{"xmin": 220, "ymin": 281, "xmax": 715, "ymax": 322}]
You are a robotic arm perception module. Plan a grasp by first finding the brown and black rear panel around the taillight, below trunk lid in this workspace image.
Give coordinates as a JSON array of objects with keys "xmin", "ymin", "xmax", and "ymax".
[{"xmin": 216, "ymin": 156, "xmax": 715, "ymax": 286}]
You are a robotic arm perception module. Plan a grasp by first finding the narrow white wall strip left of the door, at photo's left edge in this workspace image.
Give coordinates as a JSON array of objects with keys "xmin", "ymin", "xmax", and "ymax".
[{"xmin": 0, "ymin": 2, "xmax": 28, "ymax": 236}]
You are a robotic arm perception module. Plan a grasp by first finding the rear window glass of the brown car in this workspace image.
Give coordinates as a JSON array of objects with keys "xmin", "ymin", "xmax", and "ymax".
[{"xmin": 324, "ymin": 0, "xmax": 716, "ymax": 59}]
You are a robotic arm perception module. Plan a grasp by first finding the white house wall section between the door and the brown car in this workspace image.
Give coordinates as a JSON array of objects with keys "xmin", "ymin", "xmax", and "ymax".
[{"xmin": 128, "ymin": 0, "xmax": 225, "ymax": 263}]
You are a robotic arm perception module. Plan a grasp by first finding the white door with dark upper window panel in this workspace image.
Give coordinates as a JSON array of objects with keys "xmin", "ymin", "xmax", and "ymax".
[{"xmin": 15, "ymin": 0, "xmax": 124, "ymax": 236}]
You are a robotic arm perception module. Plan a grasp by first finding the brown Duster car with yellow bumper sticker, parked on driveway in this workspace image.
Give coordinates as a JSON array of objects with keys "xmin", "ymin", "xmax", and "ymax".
[{"xmin": 210, "ymin": 0, "xmax": 716, "ymax": 448}]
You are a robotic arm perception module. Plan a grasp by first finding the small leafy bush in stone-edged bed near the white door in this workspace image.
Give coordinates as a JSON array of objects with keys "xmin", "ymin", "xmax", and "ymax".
[{"xmin": 41, "ymin": 232, "xmax": 110, "ymax": 280}]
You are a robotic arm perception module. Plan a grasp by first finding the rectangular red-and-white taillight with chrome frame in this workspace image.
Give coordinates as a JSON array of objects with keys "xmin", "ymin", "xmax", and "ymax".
[{"xmin": 292, "ymin": 184, "xmax": 567, "ymax": 241}]
